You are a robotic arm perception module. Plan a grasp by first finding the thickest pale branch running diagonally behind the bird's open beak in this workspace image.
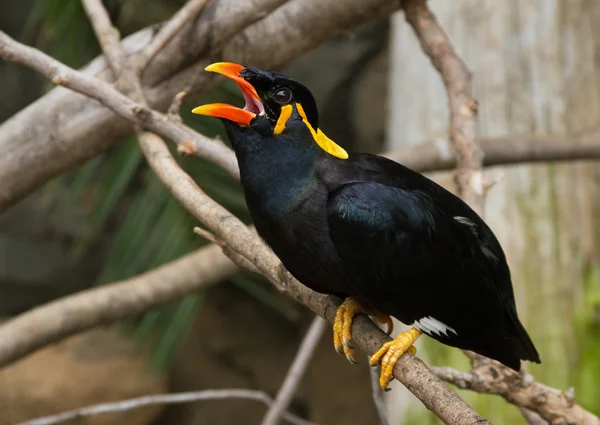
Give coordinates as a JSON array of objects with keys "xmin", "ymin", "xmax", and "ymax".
[{"xmin": 0, "ymin": 0, "xmax": 400, "ymax": 211}]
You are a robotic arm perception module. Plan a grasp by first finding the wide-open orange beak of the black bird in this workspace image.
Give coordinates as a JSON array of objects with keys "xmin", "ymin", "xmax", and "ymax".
[{"xmin": 192, "ymin": 62, "xmax": 264, "ymax": 125}]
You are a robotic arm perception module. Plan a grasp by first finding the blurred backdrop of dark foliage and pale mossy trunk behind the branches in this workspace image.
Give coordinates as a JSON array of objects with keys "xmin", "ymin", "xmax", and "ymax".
[{"xmin": 0, "ymin": 0, "xmax": 600, "ymax": 425}]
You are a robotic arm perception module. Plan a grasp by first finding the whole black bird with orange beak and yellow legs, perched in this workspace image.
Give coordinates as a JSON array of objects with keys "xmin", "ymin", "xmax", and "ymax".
[{"xmin": 193, "ymin": 62, "xmax": 540, "ymax": 388}]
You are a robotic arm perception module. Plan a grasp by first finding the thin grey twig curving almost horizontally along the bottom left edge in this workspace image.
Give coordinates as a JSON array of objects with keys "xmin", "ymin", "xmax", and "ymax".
[{"xmin": 17, "ymin": 388, "xmax": 316, "ymax": 425}]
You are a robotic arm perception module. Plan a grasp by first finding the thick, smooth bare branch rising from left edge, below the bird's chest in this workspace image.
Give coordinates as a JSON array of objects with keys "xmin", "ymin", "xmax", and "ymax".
[{"xmin": 0, "ymin": 245, "xmax": 238, "ymax": 367}]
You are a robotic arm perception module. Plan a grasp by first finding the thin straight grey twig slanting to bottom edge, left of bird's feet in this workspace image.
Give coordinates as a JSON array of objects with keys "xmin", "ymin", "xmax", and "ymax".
[{"xmin": 262, "ymin": 316, "xmax": 327, "ymax": 425}]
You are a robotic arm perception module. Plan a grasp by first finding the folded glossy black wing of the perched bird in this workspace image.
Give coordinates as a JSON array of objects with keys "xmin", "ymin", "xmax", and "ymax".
[{"xmin": 327, "ymin": 182, "xmax": 512, "ymax": 332}]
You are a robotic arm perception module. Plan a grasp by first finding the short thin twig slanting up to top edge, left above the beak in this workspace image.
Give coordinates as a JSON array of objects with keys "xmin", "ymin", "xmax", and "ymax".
[{"xmin": 136, "ymin": 0, "xmax": 209, "ymax": 74}]
